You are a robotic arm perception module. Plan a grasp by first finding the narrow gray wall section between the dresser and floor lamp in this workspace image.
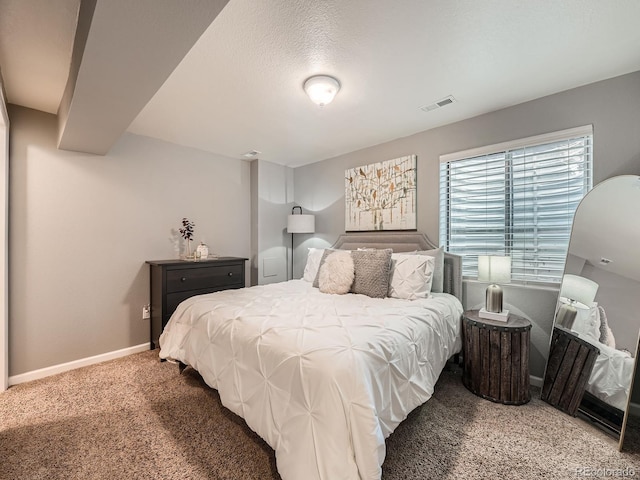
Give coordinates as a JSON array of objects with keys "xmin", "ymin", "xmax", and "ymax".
[{"xmin": 251, "ymin": 160, "xmax": 293, "ymax": 285}]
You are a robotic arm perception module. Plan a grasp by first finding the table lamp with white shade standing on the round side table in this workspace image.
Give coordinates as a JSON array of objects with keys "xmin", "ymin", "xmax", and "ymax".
[{"xmin": 478, "ymin": 255, "xmax": 511, "ymax": 322}]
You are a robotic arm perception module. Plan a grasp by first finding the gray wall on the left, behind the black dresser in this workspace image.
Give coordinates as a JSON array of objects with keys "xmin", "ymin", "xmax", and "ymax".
[{"xmin": 9, "ymin": 106, "xmax": 251, "ymax": 375}]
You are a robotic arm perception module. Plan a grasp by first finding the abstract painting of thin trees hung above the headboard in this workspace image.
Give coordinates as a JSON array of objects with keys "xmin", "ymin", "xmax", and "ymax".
[{"xmin": 344, "ymin": 155, "xmax": 417, "ymax": 232}]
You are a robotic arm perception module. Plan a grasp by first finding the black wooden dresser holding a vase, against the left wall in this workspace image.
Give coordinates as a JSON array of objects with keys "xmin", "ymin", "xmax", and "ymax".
[{"xmin": 147, "ymin": 257, "xmax": 247, "ymax": 350}]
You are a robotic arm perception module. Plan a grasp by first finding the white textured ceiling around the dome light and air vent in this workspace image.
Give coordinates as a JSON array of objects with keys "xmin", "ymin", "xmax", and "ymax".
[{"xmin": 0, "ymin": 0, "xmax": 640, "ymax": 166}]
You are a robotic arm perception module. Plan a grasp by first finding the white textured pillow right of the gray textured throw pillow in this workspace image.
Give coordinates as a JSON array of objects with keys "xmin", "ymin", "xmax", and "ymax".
[{"xmin": 389, "ymin": 253, "xmax": 435, "ymax": 300}]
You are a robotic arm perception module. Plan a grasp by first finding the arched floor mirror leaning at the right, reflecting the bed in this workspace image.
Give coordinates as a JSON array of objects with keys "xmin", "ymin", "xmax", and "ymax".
[{"xmin": 541, "ymin": 175, "xmax": 640, "ymax": 450}]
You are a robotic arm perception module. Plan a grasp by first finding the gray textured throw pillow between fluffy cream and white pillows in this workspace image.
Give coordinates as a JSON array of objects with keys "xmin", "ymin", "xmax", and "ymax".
[{"xmin": 351, "ymin": 248, "xmax": 391, "ymax": 298}]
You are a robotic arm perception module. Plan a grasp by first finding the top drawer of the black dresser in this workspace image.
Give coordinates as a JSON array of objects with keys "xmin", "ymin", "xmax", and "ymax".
[{"xmin": 167, "ymin": 264, "xmax": 244, "ymax": 292}]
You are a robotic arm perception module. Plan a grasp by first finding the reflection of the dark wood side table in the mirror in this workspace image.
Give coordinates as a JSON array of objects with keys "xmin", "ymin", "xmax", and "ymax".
[{"xmin": 540, "ymin": 326, "xmax": 600, "ymax": 416}]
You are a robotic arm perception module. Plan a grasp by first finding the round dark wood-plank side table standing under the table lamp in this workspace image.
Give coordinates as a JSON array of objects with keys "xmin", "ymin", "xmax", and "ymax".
[{"xmin": 462, "ymin": 310, "xmax": 531, "ymax": 405}]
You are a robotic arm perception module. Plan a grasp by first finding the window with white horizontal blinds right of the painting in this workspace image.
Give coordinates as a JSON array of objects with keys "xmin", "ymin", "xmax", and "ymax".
[{"xmin": 440, "ymin": 126, "xmax": 593, "ymax": 283}]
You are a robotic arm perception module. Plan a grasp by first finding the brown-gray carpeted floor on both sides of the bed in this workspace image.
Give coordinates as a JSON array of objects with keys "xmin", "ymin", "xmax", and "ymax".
[{"xmin": 0, "ymin": 351, "xmax": 640, "ymax": 480}]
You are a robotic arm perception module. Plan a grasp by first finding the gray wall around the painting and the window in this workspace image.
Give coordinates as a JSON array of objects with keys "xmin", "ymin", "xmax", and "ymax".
[{"xmin": 294, "ymin": 72, "xmax": 640, "ymax": 377}]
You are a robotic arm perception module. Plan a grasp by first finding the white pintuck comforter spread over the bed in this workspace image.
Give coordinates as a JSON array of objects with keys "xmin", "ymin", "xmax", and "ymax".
[{"xmin": 160, "ymin": 280, "xmax": 462, "ymax": 480}]
